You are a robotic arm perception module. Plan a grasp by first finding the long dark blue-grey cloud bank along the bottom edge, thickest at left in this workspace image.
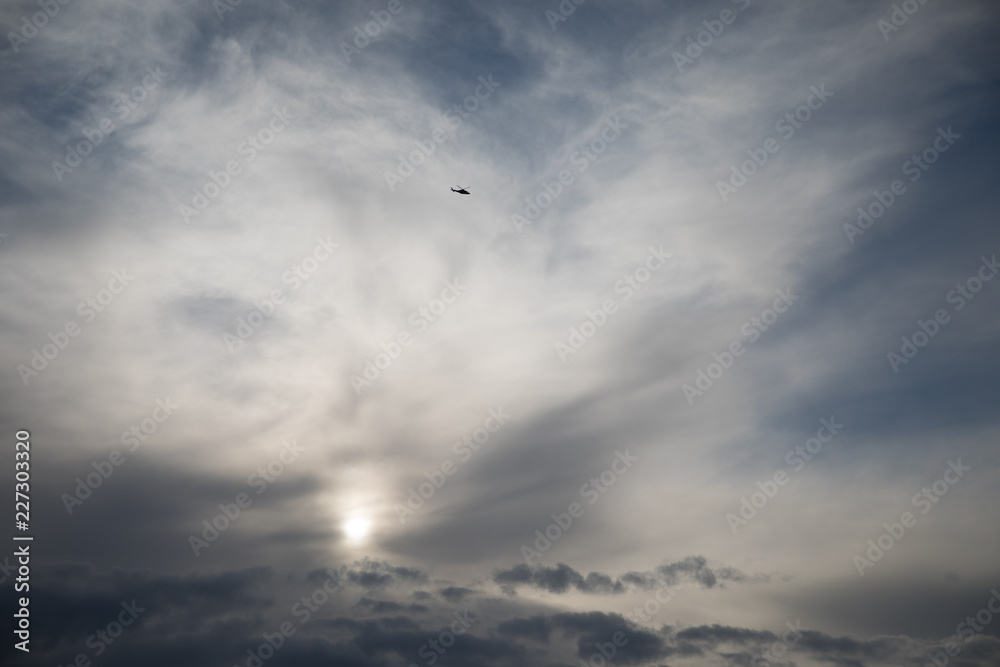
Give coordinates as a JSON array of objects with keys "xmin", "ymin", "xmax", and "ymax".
[{"xmin": 6, "ymin": 563, "xmax": 1000, "ymax": 667}]
